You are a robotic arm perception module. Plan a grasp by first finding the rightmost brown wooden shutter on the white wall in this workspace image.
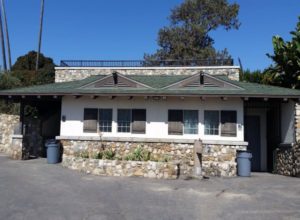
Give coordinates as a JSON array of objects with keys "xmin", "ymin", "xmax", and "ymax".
[{"xmin": 221, "ymin": 111, "xmax": 236, "ymax": 137}]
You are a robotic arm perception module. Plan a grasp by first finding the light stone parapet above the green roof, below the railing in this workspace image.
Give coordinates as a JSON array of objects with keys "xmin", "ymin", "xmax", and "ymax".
[{"xmin": 55, "ymin": 66, "xmax": 239, "ymax": 82}]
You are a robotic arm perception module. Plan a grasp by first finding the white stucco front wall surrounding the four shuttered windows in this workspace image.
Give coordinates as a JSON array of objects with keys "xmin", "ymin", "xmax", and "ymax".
[{"xmin": 61, "ymin": 97, "xmax": 244, "ymax": 141}]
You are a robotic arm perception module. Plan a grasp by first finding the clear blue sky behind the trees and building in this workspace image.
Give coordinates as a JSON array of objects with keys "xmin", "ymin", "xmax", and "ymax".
[{"xmin": 2, "ymin": 0, "xmax": 300, "ymax": 70}]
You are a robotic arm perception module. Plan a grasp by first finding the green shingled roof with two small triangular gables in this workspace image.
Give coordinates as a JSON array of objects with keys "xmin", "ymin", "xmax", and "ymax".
[{"xmin": 0, "ymin": 74, "xmax": 300, "ymax": 99}]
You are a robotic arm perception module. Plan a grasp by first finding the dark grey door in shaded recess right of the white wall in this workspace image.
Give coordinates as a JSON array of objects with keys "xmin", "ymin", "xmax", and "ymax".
[{"xmin": 245, "ymin": 115, "xmax": 261, "ymax": 171}]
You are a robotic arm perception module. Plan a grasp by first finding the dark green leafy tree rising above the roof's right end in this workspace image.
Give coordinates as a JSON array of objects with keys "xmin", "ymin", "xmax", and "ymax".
[{"xmin": 264, "ymin": 17, "xmax": 300, "ymax": 89}]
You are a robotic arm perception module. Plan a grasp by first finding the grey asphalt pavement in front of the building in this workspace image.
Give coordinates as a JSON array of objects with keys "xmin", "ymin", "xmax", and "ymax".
[{"xmin": 0, "ymin": 155, "xmax": 300, "ymax": 220}]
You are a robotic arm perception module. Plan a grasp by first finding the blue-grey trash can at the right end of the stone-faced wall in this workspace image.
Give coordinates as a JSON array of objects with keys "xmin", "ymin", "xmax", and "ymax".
[{"xmin": 237, "ymin": 151, "xmax": 252, "ymax": 177}]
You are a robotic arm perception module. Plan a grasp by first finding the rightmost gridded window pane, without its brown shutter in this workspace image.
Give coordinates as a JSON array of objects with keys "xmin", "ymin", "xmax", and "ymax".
[{"xmin": 204, "ymin": 111, "xmax": 219, "ymax": 135}]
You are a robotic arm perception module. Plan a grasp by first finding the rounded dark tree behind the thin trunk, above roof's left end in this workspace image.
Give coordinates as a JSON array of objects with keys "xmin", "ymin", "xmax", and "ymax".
[{"xmin": 12, "ymin": 51, "xmax": 55, "ymax": 86}]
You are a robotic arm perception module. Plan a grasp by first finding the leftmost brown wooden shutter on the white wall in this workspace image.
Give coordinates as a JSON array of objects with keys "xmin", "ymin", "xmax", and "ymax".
[{"xmin": 83, "ymin": 108, "xmax": 98, "ymax": 133}]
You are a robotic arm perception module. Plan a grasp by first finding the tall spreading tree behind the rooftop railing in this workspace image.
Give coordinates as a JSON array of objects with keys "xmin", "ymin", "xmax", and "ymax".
[{"xmin": 144, "ymin": 0, "xmax": 240, "ymax": 61}]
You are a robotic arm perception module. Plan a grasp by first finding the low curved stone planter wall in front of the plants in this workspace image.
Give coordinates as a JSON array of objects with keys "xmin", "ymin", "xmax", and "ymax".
[{"xmin": 62, "ymin": 155, "xmax": 177, "ymax": 179}]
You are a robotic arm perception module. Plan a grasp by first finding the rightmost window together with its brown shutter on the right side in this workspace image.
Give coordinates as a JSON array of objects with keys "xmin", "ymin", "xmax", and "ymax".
[{"xmin": 204, "ymin": 111, "xmax": 237, "ymax": 137}]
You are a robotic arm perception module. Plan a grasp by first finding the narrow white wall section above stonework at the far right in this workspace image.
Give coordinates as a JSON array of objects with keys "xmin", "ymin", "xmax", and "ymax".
[{"xmin": 281, "ymin": 100, "xmax": 295, "ymax": 143}]
